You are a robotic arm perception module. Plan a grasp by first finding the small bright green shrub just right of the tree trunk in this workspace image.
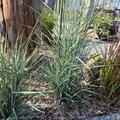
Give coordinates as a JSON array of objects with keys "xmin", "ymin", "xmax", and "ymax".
[{"xmin": 40, "ymin": 10, "xmax": 55, "ymax": 44}]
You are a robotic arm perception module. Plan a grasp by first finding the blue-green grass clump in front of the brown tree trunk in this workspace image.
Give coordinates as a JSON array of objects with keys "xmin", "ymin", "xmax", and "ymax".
[{"xmin": 0, "ymin": 40, "xmax": 40, "ymax": 120}]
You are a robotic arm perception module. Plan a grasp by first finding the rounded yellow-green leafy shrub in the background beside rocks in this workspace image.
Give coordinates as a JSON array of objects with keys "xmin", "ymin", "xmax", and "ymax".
[{"xmin": 92, "ymin": 11, "xmax": 112, "ymax": 37}]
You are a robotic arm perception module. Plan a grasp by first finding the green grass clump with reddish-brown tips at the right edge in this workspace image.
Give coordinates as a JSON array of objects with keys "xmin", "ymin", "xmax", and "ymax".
[{"xmin": 99, "ymin": 43, "xmax": 120, "ymax": 104}]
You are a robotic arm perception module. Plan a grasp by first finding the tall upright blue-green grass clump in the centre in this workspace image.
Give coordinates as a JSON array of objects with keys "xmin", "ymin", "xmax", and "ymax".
[{"xmin": 39, "ymin": 0, "xmax": 101, "ymax": 107}]
